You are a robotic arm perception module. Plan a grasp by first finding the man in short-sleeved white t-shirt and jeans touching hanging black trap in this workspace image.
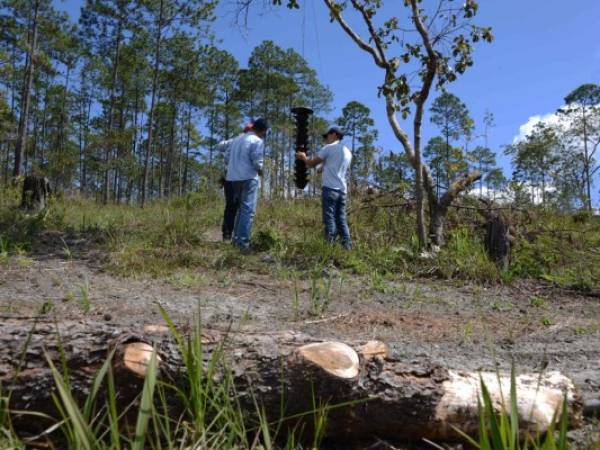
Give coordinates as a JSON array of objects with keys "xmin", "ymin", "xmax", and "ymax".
[{"xmin": 296, "ymin": 127, "xmax": 352, "ymax": 250}]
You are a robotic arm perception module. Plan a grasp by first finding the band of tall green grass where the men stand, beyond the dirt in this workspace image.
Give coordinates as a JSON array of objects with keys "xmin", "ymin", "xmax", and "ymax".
[{"xmin": 0, "ymin": 185, "xmax": 600, "ymax": 290}]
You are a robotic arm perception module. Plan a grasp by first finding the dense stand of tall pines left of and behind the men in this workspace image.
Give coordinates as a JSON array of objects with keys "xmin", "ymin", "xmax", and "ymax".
[{"xmin": 0, "ymin": 0, "xmax": 344, "ymax": 203}]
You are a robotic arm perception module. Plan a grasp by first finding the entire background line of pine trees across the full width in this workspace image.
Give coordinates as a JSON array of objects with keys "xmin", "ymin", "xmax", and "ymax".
[{"xmin": 0, "ymin": 0, "xmax": 600, "ymax": 210}]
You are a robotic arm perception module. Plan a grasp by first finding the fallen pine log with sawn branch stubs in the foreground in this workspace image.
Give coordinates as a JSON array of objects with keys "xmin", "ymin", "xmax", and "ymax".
[{"xmin": 0, "ymin": 318, "xmax": 582, "ymax": 440}]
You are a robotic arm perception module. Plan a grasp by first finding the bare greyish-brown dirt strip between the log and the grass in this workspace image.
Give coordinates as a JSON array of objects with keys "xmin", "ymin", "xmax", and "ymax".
[{"xmin": 0, "ymin": 230, "xmax": 600, "ymax": 448}]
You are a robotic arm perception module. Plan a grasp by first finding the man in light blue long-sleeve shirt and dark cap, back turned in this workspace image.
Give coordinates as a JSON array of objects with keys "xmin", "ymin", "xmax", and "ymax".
[{"xmin": 225, "ymin": 118, "xmax": 269, "ymax": 250}]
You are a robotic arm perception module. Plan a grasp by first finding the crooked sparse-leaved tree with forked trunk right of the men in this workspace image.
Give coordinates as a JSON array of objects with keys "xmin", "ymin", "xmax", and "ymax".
[{"xmin": 316, "ymin": 0, "xmax": 493, "ymax": 248}]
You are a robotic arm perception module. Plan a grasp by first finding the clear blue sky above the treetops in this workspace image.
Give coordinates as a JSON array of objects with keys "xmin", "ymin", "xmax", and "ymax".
[{"xmin": 55, "ymin": 0, "xmax": 600, "ymax": 200}]
